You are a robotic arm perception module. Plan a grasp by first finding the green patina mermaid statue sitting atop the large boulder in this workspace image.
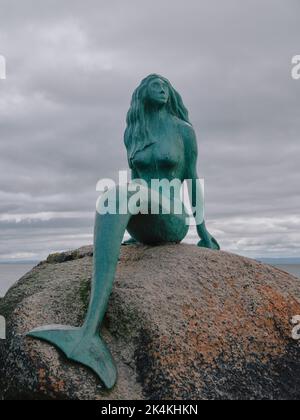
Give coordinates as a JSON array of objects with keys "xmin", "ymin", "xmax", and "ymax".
[{"xmin": 28, "ymin": 75, "xmax": 220, "ymax": 389}]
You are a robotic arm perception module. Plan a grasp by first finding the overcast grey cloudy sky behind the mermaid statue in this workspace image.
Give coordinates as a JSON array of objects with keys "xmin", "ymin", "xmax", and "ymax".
[{"xmin": 0, "ymin": 0, "xmax": 300, "ymax": 260}]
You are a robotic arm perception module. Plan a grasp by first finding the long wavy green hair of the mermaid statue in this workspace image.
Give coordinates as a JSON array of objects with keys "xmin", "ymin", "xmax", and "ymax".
[{"xmin": 124, "ymin": 74, "xmax": 190, "ymax": 167}]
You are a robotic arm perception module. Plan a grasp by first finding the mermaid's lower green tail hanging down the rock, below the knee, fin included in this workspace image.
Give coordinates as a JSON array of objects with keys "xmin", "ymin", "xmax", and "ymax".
[{"xmin": 27, "ymin": 214, "xmax": 131, "ymax": 389}]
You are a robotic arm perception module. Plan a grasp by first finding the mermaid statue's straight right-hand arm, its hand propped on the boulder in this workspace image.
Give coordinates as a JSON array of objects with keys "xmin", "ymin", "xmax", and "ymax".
[{"xmin": 184, "ymin": 125, "xmax": 220, "ymax": 249}]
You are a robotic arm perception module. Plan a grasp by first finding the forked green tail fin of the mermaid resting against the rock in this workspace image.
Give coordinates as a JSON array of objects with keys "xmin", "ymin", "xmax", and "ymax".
[{"xmin": 27, "ymin": 325, "xmax": 117, "ymax": 389}]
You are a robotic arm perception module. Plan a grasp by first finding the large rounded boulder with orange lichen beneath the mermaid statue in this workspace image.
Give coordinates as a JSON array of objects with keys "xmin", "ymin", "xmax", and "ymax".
[{"xmin": 0, "ymin": 245, "xmax": 300, "ymax": 400}]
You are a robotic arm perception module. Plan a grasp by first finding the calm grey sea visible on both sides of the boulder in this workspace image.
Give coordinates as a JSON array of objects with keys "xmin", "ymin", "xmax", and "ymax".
[{"xmin": 0, "ymin": 263, "xmax": 300, "ymax": 297}]
